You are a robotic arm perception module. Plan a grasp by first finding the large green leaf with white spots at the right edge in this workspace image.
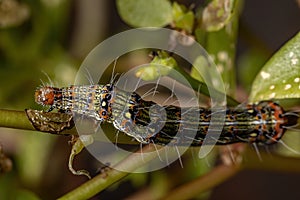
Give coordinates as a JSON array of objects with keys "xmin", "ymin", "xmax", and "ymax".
[{"xmin": 249, "ymin": 32, "xmax": 300, "ymax": 102}]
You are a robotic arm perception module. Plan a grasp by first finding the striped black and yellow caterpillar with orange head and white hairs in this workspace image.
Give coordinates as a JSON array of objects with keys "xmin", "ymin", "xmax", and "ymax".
[{"xmin": 35, "ymin": 84, "xmax": 298, "ymax": 146}]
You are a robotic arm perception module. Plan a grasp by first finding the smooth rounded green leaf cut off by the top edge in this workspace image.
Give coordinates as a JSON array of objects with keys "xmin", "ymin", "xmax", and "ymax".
[{"xmin": 117, "ymin": 0, "xmax": 172, "ymax": 27}]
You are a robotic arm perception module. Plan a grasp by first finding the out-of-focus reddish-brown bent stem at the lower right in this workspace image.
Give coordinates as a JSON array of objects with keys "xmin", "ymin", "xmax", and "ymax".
[{"xmin": 162, "ymin": 144, "xmax": 300, "ymax": 200}]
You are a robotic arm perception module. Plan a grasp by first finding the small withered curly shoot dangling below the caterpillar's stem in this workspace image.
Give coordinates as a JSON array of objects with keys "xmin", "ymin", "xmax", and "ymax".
[{"xmin": 68, "ymin": 135, "xmax": 94, "ymax": 179}]
